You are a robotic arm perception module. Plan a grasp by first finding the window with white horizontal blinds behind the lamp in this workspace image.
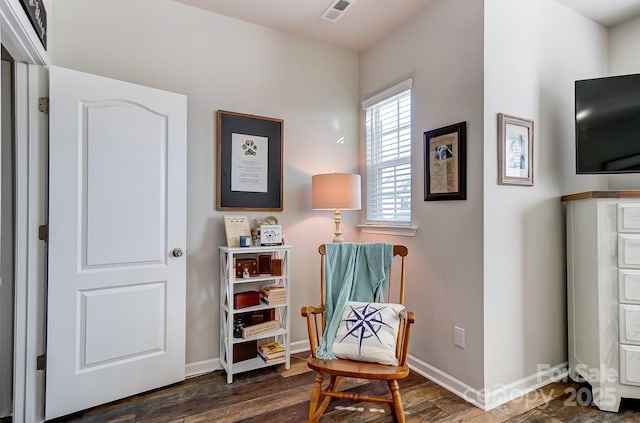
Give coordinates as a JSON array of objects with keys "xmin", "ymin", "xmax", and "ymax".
[{"xmin": 362, "ymin": 79, "xmax": 412, "ymax": 225}]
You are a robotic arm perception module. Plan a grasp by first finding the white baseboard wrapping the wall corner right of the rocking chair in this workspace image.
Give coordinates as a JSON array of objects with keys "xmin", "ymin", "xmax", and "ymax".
[{"xmin": 407, "ymin": 355, "xmax": 569, "ymax": 411}]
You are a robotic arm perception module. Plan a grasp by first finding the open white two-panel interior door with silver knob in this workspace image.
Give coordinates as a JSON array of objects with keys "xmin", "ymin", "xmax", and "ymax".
[{"xmin": 45, "ymin": 67, "xmax": 187, "ymax": 419}]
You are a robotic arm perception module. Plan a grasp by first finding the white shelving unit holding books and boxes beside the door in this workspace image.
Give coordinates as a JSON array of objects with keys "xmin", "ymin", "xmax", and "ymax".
[{"xmin": 220, "ymin": 245, "xmax": 291, "ymax": 383}]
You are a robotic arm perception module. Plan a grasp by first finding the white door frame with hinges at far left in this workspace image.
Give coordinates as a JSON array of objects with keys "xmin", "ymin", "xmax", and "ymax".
[{"xmin": 0, "ymin": 0, "xmax": 48, "ymax": 423}]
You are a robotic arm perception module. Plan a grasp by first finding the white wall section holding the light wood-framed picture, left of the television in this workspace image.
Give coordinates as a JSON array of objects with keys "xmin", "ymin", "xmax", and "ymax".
[{"xmin": 483, "ymin": 0, "xmax": 607, "ymax": 400}]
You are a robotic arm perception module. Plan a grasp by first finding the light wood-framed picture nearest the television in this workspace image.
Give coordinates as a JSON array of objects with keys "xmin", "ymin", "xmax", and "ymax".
[{"xmin": 498, "ymin": 113, "xmax": 533, "ymax": 186}]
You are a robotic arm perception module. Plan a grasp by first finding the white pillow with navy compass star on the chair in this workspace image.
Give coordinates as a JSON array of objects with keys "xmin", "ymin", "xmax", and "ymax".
[{"xmin": 332, "ymin": 301, "xmax": 405, "ymax": 366}]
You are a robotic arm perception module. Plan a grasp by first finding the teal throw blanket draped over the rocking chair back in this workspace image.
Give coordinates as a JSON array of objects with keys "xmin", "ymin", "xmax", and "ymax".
[{"xmin": 316, "ymin": 242, "xmax": 393, "ymax": 360}]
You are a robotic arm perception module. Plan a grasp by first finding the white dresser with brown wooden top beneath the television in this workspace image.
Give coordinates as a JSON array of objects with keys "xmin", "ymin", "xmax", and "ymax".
[{"xmin": 562, "ymin": 191, "xmax": 640, "ymax": 412}]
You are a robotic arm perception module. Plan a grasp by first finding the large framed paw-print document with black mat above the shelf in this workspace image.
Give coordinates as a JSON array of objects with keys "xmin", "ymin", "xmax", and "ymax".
[{"xmin": 216, "ymin": 110, "xmax": 284, "ymax": 211}]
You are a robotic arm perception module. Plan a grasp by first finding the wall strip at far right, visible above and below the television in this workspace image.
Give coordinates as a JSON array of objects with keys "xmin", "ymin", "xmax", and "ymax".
[{"xmin": 609, "ymin": 14, "xmax": 640, "ymax": 189}]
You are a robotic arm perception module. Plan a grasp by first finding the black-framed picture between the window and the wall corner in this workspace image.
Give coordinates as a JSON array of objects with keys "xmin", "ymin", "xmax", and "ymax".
[{"xmin": 424, "ymin": 121, "xmax": 467, "ymax": 201}]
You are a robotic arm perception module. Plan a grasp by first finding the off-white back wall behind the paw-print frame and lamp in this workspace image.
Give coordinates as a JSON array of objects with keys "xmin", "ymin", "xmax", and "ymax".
[{"xmin": 49, "ymin": 0, "xmax": 359, "ymax": 367}]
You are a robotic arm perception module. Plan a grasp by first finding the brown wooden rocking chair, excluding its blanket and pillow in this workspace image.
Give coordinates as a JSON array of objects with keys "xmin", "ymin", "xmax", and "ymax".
[{"xmin": 301, "ymin": 244, "xmax": 415, "ymax": 423}]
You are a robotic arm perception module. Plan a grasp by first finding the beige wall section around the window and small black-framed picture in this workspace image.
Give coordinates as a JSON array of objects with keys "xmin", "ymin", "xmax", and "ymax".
[{"xmin": 360, "ymin": 0, "xmax": 484, "ymax": 389}]
